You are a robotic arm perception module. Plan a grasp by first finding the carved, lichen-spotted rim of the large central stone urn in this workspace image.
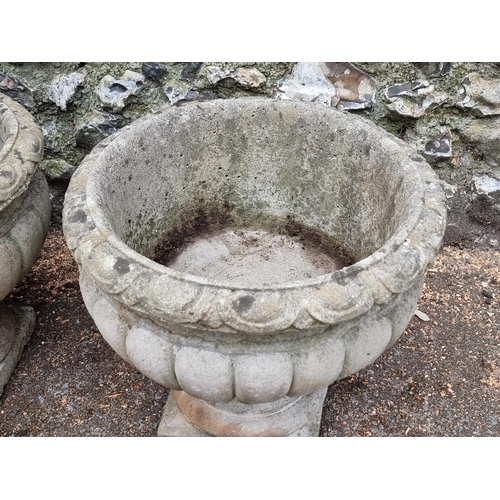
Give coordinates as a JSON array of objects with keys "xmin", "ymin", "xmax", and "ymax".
[{"xmin": 63, "ymin": 98, "xmax": 446, "ymax": 334}]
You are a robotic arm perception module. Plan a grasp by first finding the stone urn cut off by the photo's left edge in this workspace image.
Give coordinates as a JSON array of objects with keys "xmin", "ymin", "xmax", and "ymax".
[{"xmin": 0, "ymin": 94, "xmax": 50, "ymax": 394}]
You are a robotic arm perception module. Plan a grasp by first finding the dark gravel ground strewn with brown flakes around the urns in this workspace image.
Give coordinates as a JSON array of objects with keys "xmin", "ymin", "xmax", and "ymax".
[{"xmin": 0, "ymin": 185, "xmax": 500, "ymax": 437}]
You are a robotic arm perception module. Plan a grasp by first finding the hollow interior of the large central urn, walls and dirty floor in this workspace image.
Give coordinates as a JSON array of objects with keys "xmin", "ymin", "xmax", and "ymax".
[{"xmin": 88, "ymin": 101, "xmax": 422, "ymax": 287}]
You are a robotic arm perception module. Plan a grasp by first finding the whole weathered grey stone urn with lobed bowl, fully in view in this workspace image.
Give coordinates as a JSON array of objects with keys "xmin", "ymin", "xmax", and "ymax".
[{"xmin": 63, "ymin": 98, "xmax": 446, "ymax": 436}]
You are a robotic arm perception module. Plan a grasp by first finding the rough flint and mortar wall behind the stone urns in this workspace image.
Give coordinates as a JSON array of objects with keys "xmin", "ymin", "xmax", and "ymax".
[{"xmin": 0, "ymin": 62, "xmax": 500, "ymax": 248}]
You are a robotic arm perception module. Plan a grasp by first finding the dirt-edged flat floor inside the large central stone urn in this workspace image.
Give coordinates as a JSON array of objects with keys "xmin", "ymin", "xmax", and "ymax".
[{"xmin": 154, "ymin": 211, "xmax": 355, "ymax": 286}]
